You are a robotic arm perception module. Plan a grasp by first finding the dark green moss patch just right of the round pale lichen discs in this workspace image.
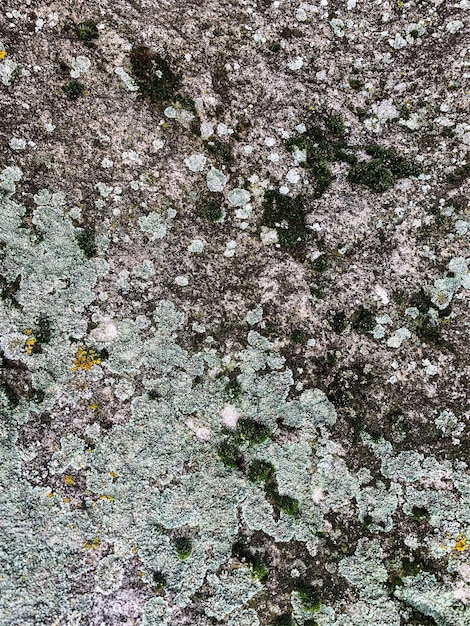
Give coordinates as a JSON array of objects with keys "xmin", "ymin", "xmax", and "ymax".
[{"xmin": 261, "ymin": 189, "xmax": 309, "ymax": 257}]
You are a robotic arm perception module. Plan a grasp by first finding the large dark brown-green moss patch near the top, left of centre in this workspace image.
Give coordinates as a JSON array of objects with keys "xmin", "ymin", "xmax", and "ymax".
[{"xmin": 130, "ymin": 45, "xmax": 181, "ymax": 103}]
